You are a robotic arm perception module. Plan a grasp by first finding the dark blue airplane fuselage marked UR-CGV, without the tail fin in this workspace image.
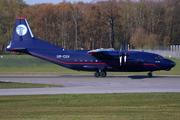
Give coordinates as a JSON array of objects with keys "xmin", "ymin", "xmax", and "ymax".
[{"xmin": 29, "ymin": 49, "xmax": 175, "ymax": 72}]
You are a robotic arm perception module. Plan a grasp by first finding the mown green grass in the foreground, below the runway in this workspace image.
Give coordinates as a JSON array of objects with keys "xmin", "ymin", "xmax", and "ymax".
[{"xmin": 0, "ymin": 93, "xmax": 180, "ymax": 120}]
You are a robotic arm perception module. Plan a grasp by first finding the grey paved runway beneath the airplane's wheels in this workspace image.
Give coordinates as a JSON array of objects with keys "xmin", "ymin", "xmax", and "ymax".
[{"xmin": 0, "ymin": 75, "xmax": 180, "ymax": 95}]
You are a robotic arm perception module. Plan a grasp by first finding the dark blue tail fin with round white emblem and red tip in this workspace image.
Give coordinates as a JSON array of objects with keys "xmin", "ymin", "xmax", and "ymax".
[{"xmin": 6, "ymin": 17, "xmax": 65, "ymax": 53}]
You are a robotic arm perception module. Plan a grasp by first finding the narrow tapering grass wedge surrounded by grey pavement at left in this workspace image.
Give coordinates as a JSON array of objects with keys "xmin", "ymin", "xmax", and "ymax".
[{"xmin": 0, "ymin": 82, "xmax": 62, "ymax": 89}]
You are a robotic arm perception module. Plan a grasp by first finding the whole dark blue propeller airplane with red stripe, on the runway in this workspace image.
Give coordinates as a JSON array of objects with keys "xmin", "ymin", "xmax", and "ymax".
[{"xmin": 6, "ymin": 17, "xmax": 176, "ymax": 77}]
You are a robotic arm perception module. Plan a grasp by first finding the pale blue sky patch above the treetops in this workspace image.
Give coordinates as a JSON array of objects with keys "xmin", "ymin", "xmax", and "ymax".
[{"xmin": 23, "ymin": 0, "xmax": 97, "ymax": 5}]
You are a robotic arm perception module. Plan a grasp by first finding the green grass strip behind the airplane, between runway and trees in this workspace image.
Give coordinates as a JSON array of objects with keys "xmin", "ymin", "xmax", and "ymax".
[{"xmin": 0, "ymin": 55, "xmax": 180, "ymax": 75}]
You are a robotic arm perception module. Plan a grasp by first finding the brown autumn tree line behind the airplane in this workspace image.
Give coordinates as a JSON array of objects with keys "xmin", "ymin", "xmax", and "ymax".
[{"xmin": 0, "ymin": 0, "xmax": 180, "ymax": 50}]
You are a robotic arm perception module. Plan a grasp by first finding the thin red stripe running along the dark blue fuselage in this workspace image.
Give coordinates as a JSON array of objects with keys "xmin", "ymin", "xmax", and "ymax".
[{"xmin": 30, "ymin": 52, "xmax": 161, "ymax": 70}]
